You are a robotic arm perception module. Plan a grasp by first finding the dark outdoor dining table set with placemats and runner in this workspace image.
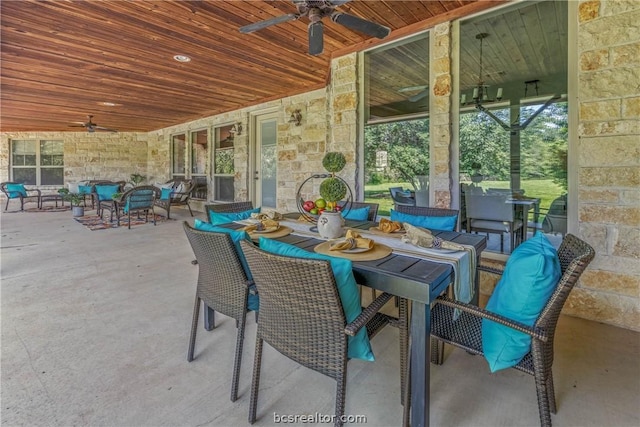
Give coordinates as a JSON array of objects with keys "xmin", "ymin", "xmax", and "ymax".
[{"xmin": 218, "ymin": 215, "xmax": 487, "ymax": 427}]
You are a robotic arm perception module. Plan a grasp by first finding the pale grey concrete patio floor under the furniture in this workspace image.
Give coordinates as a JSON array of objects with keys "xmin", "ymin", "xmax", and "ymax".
[{"xmin": 0, "ymin": 209, "xmax": 640, "ymax": 426}]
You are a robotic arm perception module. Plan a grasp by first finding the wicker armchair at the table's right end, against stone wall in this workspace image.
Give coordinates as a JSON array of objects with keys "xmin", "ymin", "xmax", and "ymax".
[{"xmin": 424, "ymin": 234, "xmax": 595, "ymax": 426}]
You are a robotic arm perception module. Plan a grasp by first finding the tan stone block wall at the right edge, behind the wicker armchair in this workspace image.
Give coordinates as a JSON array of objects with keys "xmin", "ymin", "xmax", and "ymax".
[{"xmin": 565, "ymin": 1, "xmax": 640, "ymax": 330}]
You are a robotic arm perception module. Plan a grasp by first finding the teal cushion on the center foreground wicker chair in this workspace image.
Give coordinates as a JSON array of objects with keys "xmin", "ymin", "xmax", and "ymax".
[{"xmin": 258, "ymin": 237, "xmax": 375, "ymax": 362}]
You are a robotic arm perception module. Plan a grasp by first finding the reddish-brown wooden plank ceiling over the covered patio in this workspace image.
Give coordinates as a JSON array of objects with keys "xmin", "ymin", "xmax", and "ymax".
[{"xmin": 0, "ymin": 0, "xmax": 502, "ymax": 132}]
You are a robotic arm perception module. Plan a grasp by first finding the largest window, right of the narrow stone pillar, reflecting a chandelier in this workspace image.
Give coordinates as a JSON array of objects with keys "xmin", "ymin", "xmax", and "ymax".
[{"xmin": 459, "ymin": 1, "xmax": 570, "ymax": 252}]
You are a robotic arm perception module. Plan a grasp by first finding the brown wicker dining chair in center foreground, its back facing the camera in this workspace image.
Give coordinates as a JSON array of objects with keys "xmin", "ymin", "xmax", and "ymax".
[{"xmin": 240, "ymin": 241, "xmax": 400, "ymax": 426}]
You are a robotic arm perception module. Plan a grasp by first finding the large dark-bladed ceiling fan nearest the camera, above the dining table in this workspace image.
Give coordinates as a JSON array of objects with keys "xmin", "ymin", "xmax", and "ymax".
[{"xmin": 240, "ymin": 0, "xmax": 391, "ymax": 55}]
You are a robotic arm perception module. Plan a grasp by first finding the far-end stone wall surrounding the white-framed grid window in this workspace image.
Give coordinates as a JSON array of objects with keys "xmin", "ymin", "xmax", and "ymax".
[{"xmin": 0, "ymin": 132, "xmax": 148, "ymax": 193}]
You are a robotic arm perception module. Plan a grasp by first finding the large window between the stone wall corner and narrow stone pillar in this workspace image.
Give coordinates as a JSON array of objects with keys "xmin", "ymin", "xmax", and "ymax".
[{"xmin": 364, "ymin": 33, "xmax": 429, "ymax": 215}]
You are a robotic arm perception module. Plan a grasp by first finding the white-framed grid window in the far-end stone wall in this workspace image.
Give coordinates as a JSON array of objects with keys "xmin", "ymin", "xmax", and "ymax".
[{"xmin": 11, "ymin": 140, "xmax": 64, "ymax": 185}]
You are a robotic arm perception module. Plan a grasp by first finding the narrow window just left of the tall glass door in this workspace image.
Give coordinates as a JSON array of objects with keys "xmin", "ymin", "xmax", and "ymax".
[{"xmin": 213, "ymin": 125, "xmax": 235, "ymax": 202}]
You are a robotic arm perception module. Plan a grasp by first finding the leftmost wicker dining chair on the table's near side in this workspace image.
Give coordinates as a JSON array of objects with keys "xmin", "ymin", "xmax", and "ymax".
[{"xmin": 183, "ymin": 221, "xmax": 253, "ymax": 402}]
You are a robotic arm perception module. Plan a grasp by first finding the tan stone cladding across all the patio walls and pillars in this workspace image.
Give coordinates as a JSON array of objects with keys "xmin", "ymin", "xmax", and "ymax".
[{"xmin": 0, "ymin": 1, "xmax": 640, "ymax": 330}]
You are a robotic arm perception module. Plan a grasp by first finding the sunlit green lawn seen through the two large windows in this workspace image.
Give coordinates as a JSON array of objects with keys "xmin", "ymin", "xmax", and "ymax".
[{"xmin": 364, "ymin": 179, "xmax": 564, "ymax": 216}]
